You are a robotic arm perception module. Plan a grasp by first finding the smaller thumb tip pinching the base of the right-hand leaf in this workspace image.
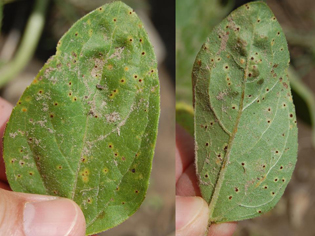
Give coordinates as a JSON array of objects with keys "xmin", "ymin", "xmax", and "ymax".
[{"xmin": 176, "ymin": 196, "xmax": 209, "ymax": 236}]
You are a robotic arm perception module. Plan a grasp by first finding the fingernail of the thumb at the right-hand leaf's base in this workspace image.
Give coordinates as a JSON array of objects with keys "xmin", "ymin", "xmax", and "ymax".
[{"xmin": 176, "ymin": 197, "xmax": 205, "ymax": 230}]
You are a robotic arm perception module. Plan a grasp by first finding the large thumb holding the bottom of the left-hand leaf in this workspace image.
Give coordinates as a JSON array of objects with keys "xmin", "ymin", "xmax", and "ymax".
[{"xmin": 0, "ymin": 189, "xmax": 85, "ymax": 236}]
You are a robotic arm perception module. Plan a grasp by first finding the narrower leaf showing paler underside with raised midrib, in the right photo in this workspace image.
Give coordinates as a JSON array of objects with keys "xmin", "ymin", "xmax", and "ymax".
[{"xmin": 193, "ymin": 2, "xmax": 297, "ymax": 222}]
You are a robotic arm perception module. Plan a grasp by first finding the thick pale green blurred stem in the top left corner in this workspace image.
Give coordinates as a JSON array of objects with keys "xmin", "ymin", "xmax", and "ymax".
[{"xmin": 0, "ymin": 0, "xmax": 49, "ymax": 88}]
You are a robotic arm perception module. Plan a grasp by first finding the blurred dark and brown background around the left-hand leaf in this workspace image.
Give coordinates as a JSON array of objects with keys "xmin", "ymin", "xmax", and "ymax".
[{"xmin": 0, "ymin": 0, "xmax": 175, "ymax": 236}]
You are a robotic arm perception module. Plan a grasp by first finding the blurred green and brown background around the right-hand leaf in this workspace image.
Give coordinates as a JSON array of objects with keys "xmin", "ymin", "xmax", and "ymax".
[{"xmin": 176, "ymin": 0, "xmax": 315, "ymax": 236}]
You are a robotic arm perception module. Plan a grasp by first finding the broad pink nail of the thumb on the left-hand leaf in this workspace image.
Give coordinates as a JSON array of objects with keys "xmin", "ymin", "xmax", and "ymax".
[{"xmin": 23, "ymin": 199, "xmax": 78, "ymax": 236}]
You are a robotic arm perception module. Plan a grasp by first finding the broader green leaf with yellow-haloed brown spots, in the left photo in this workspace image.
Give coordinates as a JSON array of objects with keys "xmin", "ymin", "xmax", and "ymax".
[{"xmin": 4, "ymin": 2, "xmax": 159, "ymax": 234}]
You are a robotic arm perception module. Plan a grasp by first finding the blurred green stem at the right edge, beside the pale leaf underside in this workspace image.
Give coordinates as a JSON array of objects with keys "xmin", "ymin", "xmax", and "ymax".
[{"xmin": 289, "ymin": 67, "xmax": 315, "ymax": 148}]
